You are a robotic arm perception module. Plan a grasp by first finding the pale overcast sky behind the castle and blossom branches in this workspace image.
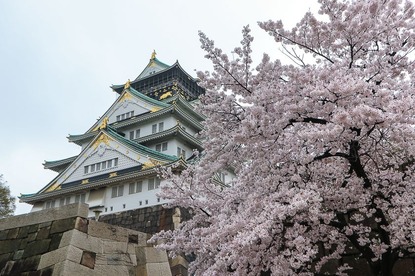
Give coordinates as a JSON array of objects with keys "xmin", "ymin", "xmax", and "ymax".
[{"xmin": 0, "ymin": 0, "xmax": 317, "ymax": 214}]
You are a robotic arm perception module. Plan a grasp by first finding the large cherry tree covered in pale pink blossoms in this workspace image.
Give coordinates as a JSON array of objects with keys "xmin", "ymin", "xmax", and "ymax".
[{"xmin": 152, "ymin": 0, "xmax": 415, "ymax": 275}]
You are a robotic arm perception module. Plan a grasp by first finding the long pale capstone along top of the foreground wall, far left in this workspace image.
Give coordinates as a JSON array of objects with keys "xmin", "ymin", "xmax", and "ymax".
[{"xmin": 0, "ymin": 203, "xmax": 88, "ymax": 231}]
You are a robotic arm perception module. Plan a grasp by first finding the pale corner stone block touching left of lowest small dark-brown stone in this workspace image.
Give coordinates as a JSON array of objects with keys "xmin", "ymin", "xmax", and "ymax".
[{"xmin": 38, "ymin": 245, "xmax": 82, "ymax": 269}]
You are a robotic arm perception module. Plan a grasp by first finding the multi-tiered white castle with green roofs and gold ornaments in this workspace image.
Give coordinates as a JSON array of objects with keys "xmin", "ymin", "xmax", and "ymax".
[{"xmin": 20, "ymin": 52, "xmax": 208, "ymax": 223}]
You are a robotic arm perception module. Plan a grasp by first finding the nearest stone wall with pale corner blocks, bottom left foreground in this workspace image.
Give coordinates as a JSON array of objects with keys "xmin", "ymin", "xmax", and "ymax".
[{"xmin": 0, "ymin": 204, "xmax": 171, "ymax": 276}]
